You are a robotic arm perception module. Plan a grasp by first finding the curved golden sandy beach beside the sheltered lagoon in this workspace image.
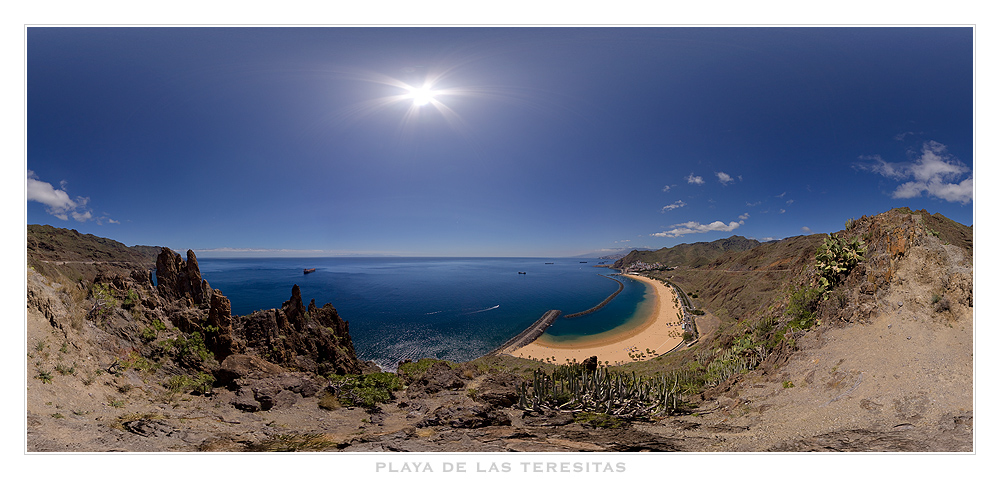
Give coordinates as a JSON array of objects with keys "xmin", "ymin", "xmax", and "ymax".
[{"xmin": 508, "ymin": 274, "xmax": 684, "ymax": 364}]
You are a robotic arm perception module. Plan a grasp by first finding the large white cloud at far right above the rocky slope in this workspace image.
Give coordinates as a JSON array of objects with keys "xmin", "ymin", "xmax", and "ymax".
[{"xmin": 858, "ymin": 141, "xmax": 973, "ymax": 204}]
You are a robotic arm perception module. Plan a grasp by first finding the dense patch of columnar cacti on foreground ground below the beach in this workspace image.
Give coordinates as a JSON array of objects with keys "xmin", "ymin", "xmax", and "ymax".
[{"xmin": 517, "ymin": 366, "xmax": 680, "ymax": 419}]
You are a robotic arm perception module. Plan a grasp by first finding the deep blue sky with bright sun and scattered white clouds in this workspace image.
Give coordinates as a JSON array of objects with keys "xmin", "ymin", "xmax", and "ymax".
[{"xmin": 24, "ymin": 27, "xmax": 974, "ymax": 256}]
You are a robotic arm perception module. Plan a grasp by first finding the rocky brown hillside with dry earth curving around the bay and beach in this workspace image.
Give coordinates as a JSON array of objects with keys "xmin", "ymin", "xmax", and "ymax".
[{"xmin": 26, "ymin": 209, "xmax": 973, "ymax": 452}]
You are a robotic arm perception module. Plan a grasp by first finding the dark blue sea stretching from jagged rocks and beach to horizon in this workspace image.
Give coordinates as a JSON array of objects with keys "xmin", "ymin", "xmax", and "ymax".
[{"xmin": 198, "ymin": 258, "xmax": 647, "ymax": 370}]
